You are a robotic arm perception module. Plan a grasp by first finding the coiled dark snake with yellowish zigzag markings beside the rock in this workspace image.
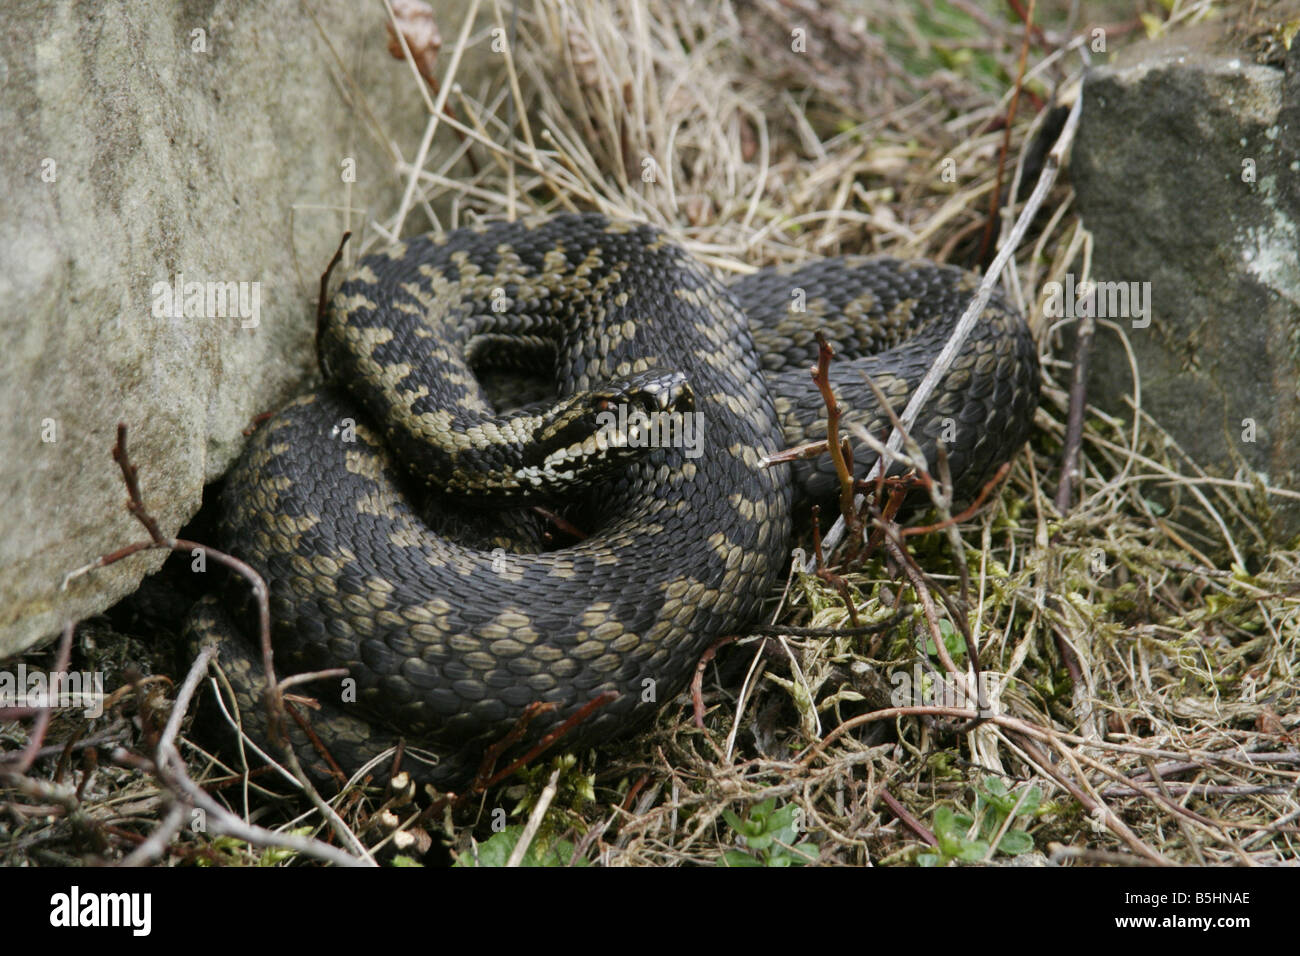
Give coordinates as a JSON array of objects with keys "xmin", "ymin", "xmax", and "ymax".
[{"xmin": 189, "ymin": 215, "xmax": 1039, "ymax": 788}]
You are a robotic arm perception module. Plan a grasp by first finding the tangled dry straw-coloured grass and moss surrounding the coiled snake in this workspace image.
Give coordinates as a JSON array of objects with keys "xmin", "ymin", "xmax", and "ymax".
[{"xmin": 8, "ymin": 0, "xmax": 1300, "ymax": 865}]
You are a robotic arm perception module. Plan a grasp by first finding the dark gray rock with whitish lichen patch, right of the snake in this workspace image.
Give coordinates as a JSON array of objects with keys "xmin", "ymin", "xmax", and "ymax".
[{"xmin": 1071, "ymin": 26, "xmax": 1300, "ymax": 535}]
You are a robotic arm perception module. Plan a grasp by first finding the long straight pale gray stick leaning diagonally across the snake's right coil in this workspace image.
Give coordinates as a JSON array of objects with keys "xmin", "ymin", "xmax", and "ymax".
[{"xmin": 805, "ymin": 69, "xmax": 1083, "ymax": 572}]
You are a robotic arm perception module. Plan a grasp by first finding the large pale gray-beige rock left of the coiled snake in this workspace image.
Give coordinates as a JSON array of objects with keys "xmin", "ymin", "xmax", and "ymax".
[{"xmin": 0, "ymin": 0, "xmax": 488, "ymax": 657}]
